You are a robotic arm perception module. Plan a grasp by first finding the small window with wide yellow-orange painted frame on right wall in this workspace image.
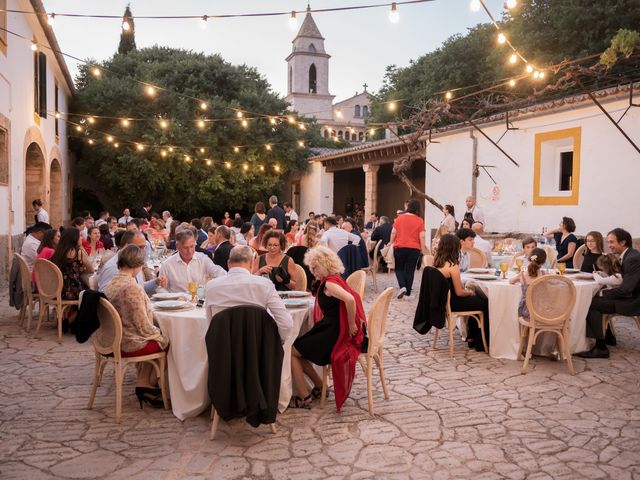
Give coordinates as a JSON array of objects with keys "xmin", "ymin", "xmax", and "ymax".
[{"xmin": 533, "ymin": 127, "xmax": 581, "ymax": 205}]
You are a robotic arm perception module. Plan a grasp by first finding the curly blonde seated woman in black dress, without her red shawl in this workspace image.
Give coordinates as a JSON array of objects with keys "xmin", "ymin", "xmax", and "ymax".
[{"xmin": 289, "ymin": 247, "xmax": 358, "ymax": 408}]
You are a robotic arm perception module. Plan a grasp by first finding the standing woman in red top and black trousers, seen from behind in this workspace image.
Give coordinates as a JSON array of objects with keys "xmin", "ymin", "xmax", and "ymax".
[{"xmin": 390, "ymin": 198, "xmax": 428, "ymax": 299}]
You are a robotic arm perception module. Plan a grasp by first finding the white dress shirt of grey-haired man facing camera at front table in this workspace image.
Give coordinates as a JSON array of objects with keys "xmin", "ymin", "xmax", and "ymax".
[{"xmin": 158, "ymin": 252, "xmax": 227, "ymax": 293}]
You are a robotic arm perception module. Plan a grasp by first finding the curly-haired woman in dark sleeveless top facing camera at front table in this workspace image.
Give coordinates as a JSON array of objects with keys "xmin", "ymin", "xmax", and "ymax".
[{"xmin": 253, "ymin": 230, "xmax": 296, "ymax": 290}]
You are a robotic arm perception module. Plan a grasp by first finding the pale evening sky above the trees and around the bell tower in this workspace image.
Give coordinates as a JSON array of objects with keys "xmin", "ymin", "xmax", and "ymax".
[{"xmin": 42, "ymin": 0, "xmax": 504, "ymax": 101}]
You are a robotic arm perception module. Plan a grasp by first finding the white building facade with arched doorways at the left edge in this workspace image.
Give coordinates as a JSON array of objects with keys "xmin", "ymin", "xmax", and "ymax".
[{"xmin": 0, "ymin": 0, "xmax": 73, "ymax": 276}]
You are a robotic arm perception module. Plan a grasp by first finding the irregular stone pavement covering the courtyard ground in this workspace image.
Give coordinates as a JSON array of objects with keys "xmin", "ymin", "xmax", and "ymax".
[{"xmin": 0, "ymin": 275, "xmax": 640, "ymax": 480}]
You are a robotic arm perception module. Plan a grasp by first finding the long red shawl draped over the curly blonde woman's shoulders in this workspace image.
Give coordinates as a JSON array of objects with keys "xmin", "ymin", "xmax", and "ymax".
[{"xmin": 313, "ymin": 274, "xmax": 367, "ymax": 412}]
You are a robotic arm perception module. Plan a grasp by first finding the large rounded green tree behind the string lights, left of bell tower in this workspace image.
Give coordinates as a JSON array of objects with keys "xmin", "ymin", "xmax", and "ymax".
[{"xmin": 72, "ymin": 46, "xmax": 323, "ymax": 215}]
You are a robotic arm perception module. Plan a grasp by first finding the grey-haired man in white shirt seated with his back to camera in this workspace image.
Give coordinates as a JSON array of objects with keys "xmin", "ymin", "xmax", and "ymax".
[{"xmin": 204, "ymin": 245, "xmax": 293, "ymax": 343}]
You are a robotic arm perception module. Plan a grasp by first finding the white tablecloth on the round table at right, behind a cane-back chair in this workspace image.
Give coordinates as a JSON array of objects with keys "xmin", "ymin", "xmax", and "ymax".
[{"xmin": 462, "ymin": 273, "xmax": 599, "ymax": 360}]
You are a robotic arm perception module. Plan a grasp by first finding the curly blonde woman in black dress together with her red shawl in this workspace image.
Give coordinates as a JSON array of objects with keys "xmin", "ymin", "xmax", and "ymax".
[{"xmin": 289, "ymin": 247, "xmax": 366, "ymax": 412}]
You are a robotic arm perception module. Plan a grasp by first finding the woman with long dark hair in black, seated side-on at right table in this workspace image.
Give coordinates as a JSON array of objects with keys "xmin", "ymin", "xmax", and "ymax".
[{"xmin": 433, "ymin": 233, "xmax": 489, "ymax": 352}]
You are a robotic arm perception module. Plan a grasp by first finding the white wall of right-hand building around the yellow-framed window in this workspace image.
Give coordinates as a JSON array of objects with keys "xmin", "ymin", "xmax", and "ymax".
[{"xmin": 426, "ymin": 97, "xmax": 640, "ymax": 237}]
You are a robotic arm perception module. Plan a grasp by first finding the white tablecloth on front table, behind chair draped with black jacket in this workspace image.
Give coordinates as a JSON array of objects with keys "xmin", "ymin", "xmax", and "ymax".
[{"xmin": 154, "ymin": 307, "xmax": 313, "ymax": 420}]
